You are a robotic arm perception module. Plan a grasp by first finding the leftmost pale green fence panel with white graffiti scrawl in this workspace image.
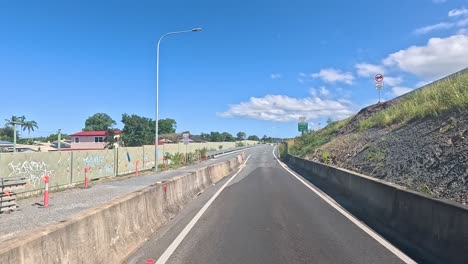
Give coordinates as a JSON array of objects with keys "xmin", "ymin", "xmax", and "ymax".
[{"xmin": 0, "ymin": 152, "xmax": 71, "ymax": 193}]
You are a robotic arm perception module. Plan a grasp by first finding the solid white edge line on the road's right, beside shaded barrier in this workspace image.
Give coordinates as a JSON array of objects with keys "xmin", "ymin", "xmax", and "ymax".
[{"xmin": 273, "ymin": 146, "xmax": 417, "ymax": 263}]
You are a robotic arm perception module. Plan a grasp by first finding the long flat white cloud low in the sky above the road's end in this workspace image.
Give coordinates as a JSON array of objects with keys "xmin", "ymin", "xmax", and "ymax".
[{"xmin": 217, "ymin": 94, "xmax": 353, "ymax": 122}]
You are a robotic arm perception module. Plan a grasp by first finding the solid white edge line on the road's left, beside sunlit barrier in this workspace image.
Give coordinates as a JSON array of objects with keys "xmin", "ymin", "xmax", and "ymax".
[{"xmin": 156, "ymin": 154, "xmax": 252, "ymax": 264}]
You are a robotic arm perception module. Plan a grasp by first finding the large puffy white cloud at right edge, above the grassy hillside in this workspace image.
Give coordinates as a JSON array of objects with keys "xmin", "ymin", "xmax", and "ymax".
[{"xmin": 383, "ymin": 35, "xmax": 468, "ymax": 80}]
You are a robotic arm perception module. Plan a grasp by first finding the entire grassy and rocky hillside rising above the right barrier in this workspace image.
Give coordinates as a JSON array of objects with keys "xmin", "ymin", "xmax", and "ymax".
[{"xmin": 289, "ymin": 69, "xmax": 468, "ymax": 204}]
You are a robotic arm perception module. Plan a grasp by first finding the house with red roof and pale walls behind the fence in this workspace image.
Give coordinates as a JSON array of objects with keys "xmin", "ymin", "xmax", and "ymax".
[{"xmin": 70, "ymin": 130, "xmax": 122, "ymax": 149}]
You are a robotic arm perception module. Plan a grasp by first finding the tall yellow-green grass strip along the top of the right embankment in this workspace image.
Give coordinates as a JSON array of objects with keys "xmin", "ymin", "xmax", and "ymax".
[{"xmin": 359, "ymin": 73, "xmax": 468, "ymax": 130}]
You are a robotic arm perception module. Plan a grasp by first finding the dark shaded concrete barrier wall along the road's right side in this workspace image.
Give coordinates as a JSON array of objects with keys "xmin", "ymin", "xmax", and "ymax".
[{"xmin": 286, "ymin": 155, "xmax": 468, "ymax": 263}]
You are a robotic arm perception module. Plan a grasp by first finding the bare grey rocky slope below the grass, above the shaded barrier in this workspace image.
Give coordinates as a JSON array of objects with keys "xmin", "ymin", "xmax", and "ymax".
[{"xmin": 308, "ymin": 108, "xmax": 468, "ymax": 204}]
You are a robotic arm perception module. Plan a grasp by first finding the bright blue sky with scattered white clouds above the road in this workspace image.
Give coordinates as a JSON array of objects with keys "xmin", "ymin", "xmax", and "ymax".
[{"xmin": 0, "ymin": 0, "xmax": 468, "ymax": 137}]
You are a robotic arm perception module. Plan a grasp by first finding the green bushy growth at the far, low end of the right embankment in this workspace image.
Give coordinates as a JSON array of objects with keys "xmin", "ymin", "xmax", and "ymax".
[{"xmin": 290, "ymin": 117, "xmax": 351, "ymax": 157}]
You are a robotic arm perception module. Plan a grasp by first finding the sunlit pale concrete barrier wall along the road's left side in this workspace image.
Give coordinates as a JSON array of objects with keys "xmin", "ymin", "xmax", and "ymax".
[{"xmin": 0, "ymin": 155, "xmax": 243, "ymax": 264}]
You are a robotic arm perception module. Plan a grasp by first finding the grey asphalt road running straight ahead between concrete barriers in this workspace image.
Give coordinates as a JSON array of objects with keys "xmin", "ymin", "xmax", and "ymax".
[{"xmin": 127, "ymin": 146, "xmax": 414, "ymax": 264}]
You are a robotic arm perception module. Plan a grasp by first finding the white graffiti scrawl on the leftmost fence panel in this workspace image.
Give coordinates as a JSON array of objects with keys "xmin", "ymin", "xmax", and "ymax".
[{"xmin": 8, "ymin": 161, "xmax": 54, "ymax": 187}]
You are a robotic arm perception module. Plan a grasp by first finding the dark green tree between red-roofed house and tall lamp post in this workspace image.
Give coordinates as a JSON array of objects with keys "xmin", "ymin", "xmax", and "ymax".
[{"xmin": 121, "ymin": 114, "xmax": 156, "ymax": 147}]
